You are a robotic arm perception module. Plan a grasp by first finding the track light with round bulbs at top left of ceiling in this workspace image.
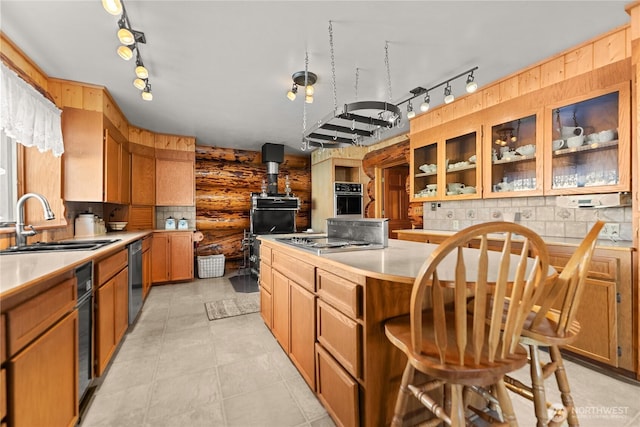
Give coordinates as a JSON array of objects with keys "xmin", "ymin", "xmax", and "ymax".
[{"xmin": 102, "ymin": 0, "xmax": 153, "ymax": 101}]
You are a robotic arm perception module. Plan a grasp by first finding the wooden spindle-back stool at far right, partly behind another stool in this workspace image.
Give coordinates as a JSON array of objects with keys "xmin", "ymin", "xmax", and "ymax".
[{"xmin": 505, "ymin": 221, "xmax": 604, "ymax": 427}]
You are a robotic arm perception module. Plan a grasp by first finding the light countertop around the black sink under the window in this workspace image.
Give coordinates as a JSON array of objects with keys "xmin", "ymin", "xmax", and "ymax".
[{"xmin": 0, "ymin": 231, "xmax": 151, "ymax": 299}]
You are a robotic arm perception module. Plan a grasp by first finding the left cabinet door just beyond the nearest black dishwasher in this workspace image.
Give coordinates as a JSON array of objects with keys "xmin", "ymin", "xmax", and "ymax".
[{"xmin": 94, "ymin": 278, "xmax": 116, "ymax": 376}]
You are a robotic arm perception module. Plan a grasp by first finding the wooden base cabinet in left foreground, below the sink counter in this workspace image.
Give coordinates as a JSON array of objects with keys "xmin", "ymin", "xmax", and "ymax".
[{"xmin": 0, "ymin": 270, "xmax": 78, "ymax": 427}]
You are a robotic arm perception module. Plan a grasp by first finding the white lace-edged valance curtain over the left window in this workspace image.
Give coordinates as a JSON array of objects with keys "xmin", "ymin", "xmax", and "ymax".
[{"xmin": 0, "ymin": 63, "xmax": 64, "ymax": 157}]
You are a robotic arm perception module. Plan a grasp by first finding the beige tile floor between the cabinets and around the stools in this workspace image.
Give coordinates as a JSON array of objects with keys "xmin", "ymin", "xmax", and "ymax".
[{"xmin": 80, "ymin": 274, "xmax": 640, "ymax": 427}]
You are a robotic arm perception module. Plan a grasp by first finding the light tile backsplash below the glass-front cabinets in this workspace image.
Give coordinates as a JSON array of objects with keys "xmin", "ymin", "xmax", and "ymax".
[{"xmin": 423, "ymin": 196, "xmax": 632, "ymax": 240}]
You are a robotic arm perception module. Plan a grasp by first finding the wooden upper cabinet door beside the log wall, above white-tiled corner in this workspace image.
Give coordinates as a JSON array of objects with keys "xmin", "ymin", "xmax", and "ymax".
[{"xmin": 156, "ymin": 159, "xmax": 195, "ymax": 206}]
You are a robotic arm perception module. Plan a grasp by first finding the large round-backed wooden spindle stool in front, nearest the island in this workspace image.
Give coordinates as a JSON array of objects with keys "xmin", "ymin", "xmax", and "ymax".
[{"xmin": 385, "ymin": 222, "xmax": 549, "ymax": 426}]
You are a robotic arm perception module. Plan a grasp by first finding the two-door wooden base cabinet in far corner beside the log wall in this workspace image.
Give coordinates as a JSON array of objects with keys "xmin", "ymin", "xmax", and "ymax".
[{"xmin": 151, "ymin": 231, "xmax": 193, "ymax": 283}]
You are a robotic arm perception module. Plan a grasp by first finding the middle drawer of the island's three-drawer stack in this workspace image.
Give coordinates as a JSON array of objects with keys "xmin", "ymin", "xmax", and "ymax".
[{"xmin": 318, "ymin": 300, "xmax": 362, "ymax": 378}]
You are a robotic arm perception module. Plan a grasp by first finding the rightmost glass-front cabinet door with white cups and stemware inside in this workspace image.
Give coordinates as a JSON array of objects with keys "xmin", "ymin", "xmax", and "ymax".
[{"xmin": 544, "ymin": 83, "xmax": 631, "ymax": 194}]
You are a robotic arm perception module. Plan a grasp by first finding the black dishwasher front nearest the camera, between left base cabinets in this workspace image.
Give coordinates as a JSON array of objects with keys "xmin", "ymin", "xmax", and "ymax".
[{"xmin": 76, "ymin": 262, "xmax": 93, "ymax": 402}]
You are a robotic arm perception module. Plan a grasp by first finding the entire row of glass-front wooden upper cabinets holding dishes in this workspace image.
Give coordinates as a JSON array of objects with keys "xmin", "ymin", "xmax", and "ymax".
[{"xmin": 411, "ymin": 82, "xmax": 631, "ymax": 201}]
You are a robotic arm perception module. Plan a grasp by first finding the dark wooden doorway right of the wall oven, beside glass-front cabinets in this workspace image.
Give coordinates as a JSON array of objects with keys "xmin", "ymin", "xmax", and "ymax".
[{"xmin": 381, "ymin": 163, "xmax": 411, "ymax": 239}]
